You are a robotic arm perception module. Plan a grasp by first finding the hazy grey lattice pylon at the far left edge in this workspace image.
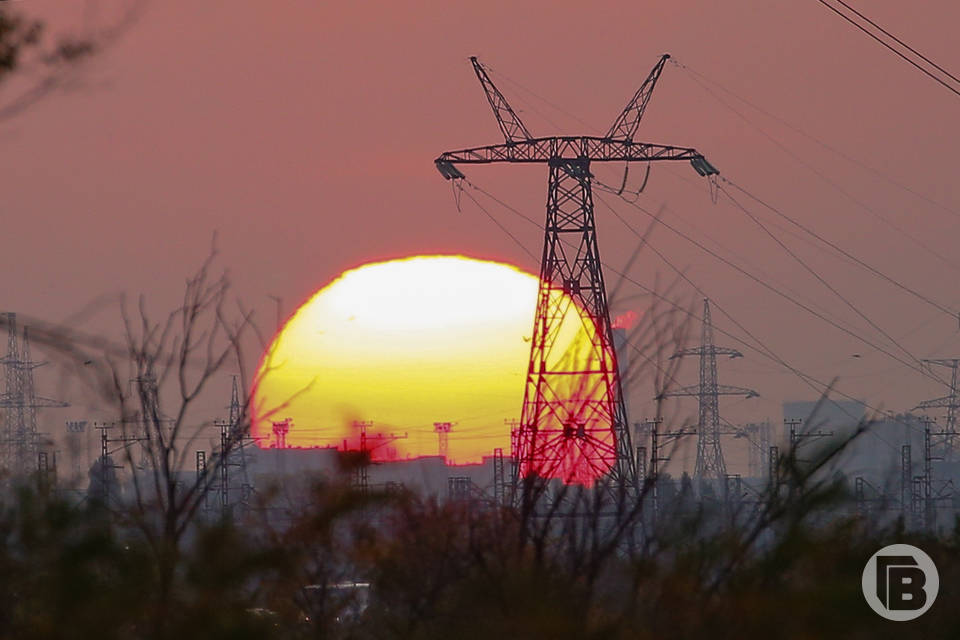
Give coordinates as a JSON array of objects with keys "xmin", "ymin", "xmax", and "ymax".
[{"xmin": 0, "ymin": 313, "xmax": 69, "ymax": 478}]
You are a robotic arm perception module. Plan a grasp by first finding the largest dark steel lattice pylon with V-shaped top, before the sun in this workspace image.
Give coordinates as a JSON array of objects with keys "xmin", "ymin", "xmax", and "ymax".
[{"xmin": 435, "ymin": 55, "xmax": 718, "ymax": 487}]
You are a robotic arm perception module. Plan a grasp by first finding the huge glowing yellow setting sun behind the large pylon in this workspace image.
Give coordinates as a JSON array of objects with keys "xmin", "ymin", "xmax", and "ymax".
[{"xmin": 252, "ymin": 256, "xmax": 600, "ymax": 464}]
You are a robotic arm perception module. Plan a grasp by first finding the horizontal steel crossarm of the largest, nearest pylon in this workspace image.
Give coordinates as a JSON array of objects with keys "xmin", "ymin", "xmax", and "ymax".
[{"xmin": 434, "ymin": 136, "xmax": 704, "ymax": 168}]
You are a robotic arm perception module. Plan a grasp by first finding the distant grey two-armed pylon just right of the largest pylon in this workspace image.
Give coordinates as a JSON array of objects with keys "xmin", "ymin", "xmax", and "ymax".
[{"xmin": 663, "ymin": 298, "xmax": 759, "ymax": 480}]
